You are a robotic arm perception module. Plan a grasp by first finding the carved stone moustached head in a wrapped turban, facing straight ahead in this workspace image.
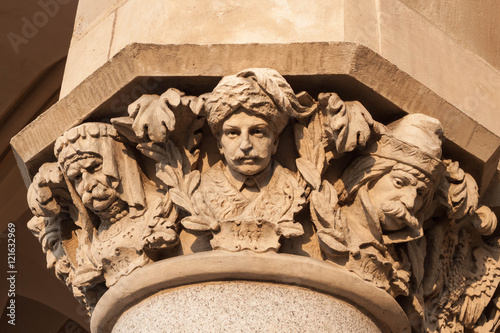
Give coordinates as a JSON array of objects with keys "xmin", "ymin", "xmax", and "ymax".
[{"xmin": 205, "ymin": 68, "xmax": 312, "ymax": 175}]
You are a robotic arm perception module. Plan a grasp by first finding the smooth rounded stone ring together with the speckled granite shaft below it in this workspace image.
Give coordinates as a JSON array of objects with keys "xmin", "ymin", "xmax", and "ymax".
[{"xmin": 91, "ymin": 251, "xmax": 410, "ymax": 333}]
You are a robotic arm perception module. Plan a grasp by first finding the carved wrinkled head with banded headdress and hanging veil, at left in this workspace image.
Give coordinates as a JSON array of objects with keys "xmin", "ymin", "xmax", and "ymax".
[{"xmin": 54, "ymin": 123, "xmax": 145, "ymax": 218}]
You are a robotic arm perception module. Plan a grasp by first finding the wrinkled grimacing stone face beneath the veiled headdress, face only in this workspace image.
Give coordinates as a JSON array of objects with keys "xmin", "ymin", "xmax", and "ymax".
[{"xmin": 67, "ymin": 157, "xmax": 118, "ymax": 212}]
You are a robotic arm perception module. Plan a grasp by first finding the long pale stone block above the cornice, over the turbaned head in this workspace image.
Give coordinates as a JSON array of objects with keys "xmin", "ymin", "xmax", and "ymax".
[{"xmin": 111, "ymin": 0, "xmax": 344, "ymax": 55}]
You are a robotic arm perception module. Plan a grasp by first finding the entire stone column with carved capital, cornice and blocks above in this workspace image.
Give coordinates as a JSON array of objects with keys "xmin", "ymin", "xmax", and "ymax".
[{"xmin": 12, "ymin": 0, "xmax": 500, "ymax": 333}]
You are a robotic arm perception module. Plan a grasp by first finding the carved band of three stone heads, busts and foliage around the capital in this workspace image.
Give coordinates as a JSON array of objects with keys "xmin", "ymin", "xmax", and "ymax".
[{"xmin": 28, "ymin": 69, "xmax": 500, "ymax": 332}]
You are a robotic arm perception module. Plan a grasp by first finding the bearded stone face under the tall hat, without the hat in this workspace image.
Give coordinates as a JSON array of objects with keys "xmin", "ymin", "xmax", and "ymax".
[{"xmin": 368, "ymin": 170, "xmax": 428, "ymax": 231}]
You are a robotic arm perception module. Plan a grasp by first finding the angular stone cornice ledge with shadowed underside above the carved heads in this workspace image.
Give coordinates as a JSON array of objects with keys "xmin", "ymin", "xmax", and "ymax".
[{"xmin": 11, "ymin": 42, "xmax": 500, "ymax": 191}]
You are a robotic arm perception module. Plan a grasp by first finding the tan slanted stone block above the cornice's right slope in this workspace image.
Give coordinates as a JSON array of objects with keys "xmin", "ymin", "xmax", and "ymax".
[{"xmin": 380, "ymin": 1, "xmax": 500, "ymax": 135}]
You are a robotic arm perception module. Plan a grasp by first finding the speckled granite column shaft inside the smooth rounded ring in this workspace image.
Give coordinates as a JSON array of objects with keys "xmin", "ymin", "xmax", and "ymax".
[{"xmin": 112, "ymin": 281, "xmax": 381, "ymax": 333}]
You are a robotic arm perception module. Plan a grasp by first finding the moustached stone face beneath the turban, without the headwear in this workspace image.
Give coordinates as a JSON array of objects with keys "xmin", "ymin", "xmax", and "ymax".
[{"xmin": 219, "ymin": 109, "xmax": 278, "ymax": 176}]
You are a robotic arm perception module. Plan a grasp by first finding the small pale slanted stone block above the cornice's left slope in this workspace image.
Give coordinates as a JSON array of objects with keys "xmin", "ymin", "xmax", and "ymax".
[{"xmin": 60, "ymin": 14, "xmax": 114, "ymax": 98}]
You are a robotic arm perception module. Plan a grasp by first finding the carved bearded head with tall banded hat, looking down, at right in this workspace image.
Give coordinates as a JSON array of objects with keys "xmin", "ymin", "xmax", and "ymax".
[{"xmin": 341, "ymin": 114, "xmax": 444, "ymax": 236}]
